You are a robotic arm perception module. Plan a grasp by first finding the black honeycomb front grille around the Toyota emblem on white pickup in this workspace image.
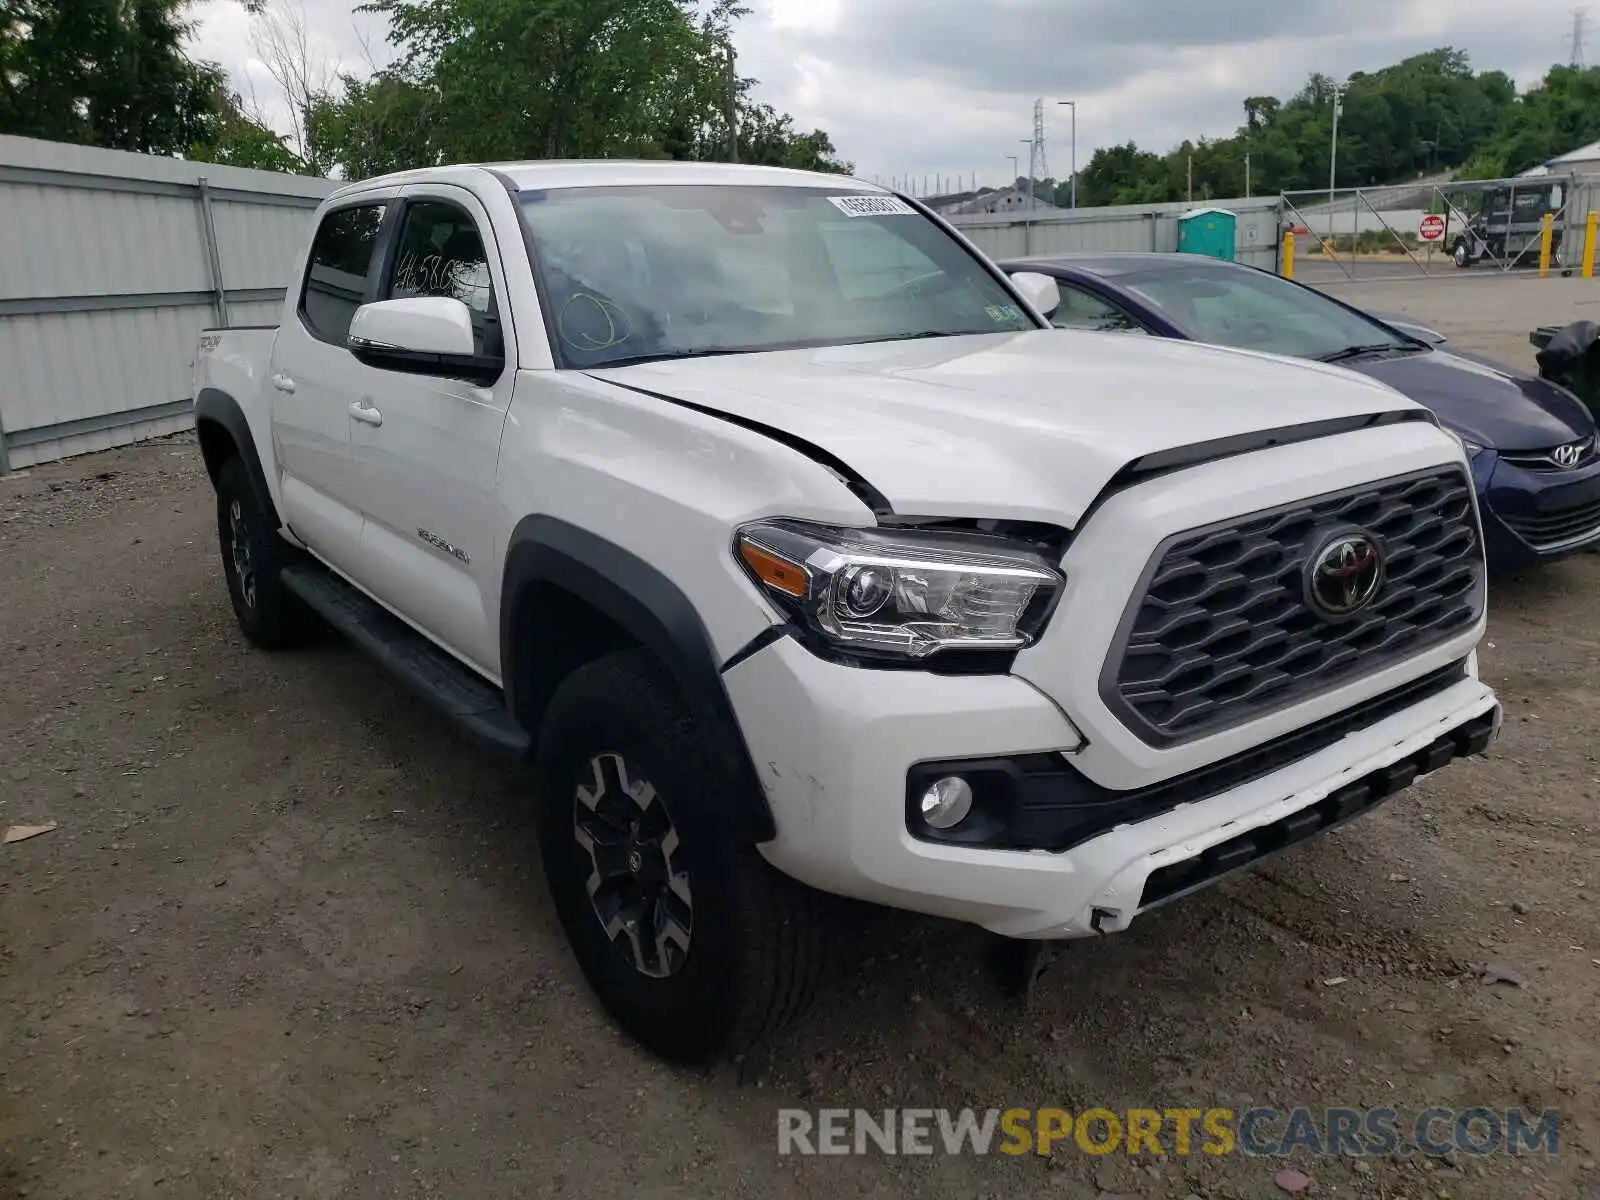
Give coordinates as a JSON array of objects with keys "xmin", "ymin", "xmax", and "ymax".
[{"xmin": 1101, "ymin": 467, "xmax": 1485, "ymax": 746}]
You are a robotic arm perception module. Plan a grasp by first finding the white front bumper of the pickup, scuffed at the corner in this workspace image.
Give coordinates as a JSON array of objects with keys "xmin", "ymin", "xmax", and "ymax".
[{"xmin": 725, "ymin": 638, "xmax": 1499, "ymax": 938}]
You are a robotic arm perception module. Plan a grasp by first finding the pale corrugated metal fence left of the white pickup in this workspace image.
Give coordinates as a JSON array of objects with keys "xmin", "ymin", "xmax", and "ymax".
[{"xmin": 0, "ymin": 136, "xmax": 336, "ymax": 474}]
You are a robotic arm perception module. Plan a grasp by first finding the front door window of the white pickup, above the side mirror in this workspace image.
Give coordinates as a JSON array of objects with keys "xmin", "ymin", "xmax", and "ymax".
[{"xmin": 386, "ymin": 200, "xmax": 506, "ymax": 355}]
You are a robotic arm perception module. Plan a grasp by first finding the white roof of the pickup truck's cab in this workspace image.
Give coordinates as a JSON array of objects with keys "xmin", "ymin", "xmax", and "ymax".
[{"xmin": 330, "ymin": 158, "xmax": 886, "ymax": 200}]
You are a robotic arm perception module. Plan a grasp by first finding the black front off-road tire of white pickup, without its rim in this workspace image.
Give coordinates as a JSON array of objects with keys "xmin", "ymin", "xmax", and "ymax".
[{"xmin": 536, "ymin": 650, "xmax": 826, "ymax": 1064}]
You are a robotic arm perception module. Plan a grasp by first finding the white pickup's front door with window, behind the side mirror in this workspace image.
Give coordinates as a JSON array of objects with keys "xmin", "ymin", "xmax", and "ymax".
[{"xmin": 350, "ymin": 184, "xmax": 517, "ymax": 680}]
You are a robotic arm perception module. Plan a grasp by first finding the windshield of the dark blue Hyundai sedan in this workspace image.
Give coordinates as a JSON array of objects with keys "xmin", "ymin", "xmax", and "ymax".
[{"xmin": 1117, "ymin": 266, "xmax": 1414, "ymax": 358}]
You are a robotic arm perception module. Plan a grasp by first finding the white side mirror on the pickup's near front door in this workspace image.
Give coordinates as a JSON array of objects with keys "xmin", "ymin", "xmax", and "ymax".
[{"xmin": 346, "ymin": 296, "xmax": 506, "ymax": 384}]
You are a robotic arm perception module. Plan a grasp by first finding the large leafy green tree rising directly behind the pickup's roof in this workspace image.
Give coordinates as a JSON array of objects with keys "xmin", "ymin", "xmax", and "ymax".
[{"xmin": 306, "ymin": 0, "xmax": 848, "ymax": 178}]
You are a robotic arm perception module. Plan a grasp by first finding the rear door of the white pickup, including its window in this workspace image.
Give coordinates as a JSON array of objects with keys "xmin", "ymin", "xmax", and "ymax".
[{"xmin": 267, "ymin": 189, "xmax": 394, "ymax": 573}]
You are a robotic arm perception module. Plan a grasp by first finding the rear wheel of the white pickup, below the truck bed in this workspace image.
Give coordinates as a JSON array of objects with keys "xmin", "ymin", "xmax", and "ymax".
[{"xmin": 216, "ymin": 458, "xmax": 317, "ymax": 650}]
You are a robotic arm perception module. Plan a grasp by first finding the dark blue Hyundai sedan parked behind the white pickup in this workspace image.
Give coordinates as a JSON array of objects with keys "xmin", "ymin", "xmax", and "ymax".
[{"xmin": 1000, "ymin": 253, "xmax": 1600, "ymax": 571}]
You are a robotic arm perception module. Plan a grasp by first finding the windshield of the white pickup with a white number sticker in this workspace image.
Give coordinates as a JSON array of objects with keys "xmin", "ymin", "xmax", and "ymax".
[{"xmin": 518, "ymin": 184, "xmax": 1038, "ymax": 366}]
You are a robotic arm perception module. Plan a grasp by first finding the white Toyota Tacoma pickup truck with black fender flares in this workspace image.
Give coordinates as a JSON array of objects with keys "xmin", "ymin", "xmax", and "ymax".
[{"xmin": 194, "ymin": 162, "xmax": 1499, "ymax": 1061}]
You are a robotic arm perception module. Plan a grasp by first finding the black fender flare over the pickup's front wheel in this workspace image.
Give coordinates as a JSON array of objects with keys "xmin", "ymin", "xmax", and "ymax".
[{"xmin": 499, "ymin": 515, "xmax": 778, "ymax": 842}]
